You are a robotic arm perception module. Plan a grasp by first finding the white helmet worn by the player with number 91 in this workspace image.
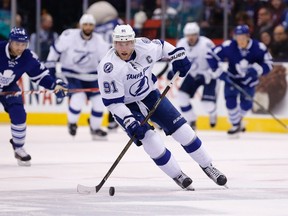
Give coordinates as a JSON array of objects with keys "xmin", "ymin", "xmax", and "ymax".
[{"xmin": 112, "ymin": 24, "xmax": 135, "ymax": 42}]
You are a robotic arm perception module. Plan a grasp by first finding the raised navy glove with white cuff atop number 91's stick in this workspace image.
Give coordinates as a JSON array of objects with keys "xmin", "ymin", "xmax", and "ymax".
[{"xmin": 168, "ymin": 47, "xmax": 191, "ymax": 77}]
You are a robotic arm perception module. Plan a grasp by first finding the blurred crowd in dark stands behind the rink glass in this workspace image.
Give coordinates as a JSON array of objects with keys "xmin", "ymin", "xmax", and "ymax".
[{"xmin": 0, "ymin": 0, "xmax": 288, "ymax": 61}]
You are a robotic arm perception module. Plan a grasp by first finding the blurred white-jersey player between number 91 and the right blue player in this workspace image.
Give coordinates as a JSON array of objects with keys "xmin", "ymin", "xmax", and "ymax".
[{"xmin": 168, "ymin": 22, "xmax": 218, "ymax": 130}]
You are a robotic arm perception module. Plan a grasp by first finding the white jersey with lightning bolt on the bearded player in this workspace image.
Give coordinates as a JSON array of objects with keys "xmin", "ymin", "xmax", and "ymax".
[{"xmin": 47, "ymin": 29, "xmax": 110, "ymax": 81}]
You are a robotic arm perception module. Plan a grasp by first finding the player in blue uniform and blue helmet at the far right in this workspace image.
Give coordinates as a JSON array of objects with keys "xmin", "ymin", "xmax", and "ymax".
[{"xmin": 207, "ymin": 25, "xmax": 272, "ymax": 136}]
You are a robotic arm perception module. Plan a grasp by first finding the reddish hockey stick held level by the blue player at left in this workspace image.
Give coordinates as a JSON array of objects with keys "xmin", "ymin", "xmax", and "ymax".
[{"xmin": 0, "ymin": 88, "xmax": 99, "ymax": 96}]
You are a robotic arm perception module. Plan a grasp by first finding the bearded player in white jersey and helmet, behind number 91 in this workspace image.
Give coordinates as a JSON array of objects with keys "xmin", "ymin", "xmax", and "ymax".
[{"xmin": 46, "ymin": 14, "xmax": 110, "ymax": 140}]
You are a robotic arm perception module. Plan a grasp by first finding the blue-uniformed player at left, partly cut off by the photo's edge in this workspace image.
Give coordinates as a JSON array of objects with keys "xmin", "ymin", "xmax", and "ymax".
[{"xmin": 0, "ymin": 27, "xmax": 68, "ymax": 166}]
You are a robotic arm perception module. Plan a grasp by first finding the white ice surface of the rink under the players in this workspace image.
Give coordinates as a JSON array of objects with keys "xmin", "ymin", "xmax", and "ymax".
[{"xmin": 0, "ymin": 124, "xmax": 288, "ymax": 216}]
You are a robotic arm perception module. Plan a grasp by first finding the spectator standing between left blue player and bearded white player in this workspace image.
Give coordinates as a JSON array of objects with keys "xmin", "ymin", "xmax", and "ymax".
[{"xmin": 30, "ymin": 13, "xmax": 58, "ymax": 61}]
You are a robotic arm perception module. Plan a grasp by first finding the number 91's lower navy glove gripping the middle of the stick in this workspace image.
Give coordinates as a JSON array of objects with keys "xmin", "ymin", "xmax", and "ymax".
[{"xmin": 124, "ymin": 116, "xmax": 149, "ymax": 140}]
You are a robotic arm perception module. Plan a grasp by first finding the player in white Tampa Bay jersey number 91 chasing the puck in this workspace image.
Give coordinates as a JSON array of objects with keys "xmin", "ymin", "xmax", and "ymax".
[{"xmin": 98, "ymin": 25, "xmax": 227, "ymax": 190}]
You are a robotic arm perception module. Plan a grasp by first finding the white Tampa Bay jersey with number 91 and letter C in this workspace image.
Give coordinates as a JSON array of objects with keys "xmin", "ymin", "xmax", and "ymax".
[{"xmin": 98, "ymin": 38, "xmax": 175, "ymax": 106}]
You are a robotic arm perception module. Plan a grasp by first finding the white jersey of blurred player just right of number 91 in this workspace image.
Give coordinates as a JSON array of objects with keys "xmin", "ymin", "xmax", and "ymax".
[{"xmin": 176, "ymin": 36, "xmax": 215, "ymax": 83}]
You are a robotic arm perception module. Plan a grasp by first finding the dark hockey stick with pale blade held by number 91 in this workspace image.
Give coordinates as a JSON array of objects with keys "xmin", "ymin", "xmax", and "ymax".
[{"xmin": 77, "ymin": 72, "xmax": 179, "ymax": 194}]
